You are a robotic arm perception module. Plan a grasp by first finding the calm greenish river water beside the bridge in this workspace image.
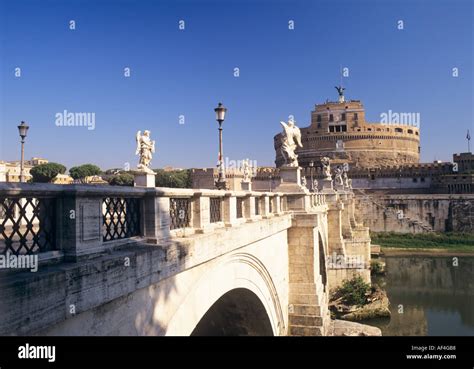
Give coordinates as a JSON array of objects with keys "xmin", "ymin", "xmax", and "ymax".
[{"xmin": 366, "ymin": 256, "xmax": 474, "ymax": 336}]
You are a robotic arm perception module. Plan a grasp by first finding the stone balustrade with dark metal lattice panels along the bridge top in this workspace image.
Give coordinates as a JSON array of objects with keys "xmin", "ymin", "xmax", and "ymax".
[{"xmin": 0, "ymin": 183, "xmax": 325, "ymax": 260}]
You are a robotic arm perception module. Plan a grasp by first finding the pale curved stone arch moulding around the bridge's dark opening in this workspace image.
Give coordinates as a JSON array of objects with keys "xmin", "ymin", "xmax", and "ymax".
[{"xmin": 166, "ymin": 253, "xmax": 286, "ymax": 336}]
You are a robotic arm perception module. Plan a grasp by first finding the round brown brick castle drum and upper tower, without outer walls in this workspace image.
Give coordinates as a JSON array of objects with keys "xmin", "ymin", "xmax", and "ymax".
[{"xmin": 274, "ymin": 87, "xmax": 420, "ymax": 168}]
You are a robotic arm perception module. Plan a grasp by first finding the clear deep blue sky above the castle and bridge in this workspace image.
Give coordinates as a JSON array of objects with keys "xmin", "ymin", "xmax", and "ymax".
[{"xmin": 0, "ymin": 0, "xmax": 474, "ymax": 169}]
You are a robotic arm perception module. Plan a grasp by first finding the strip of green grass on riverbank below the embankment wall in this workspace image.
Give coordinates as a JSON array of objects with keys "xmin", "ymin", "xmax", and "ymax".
[{"xmin": 370, "ymin": 232, "xmax": 474, "ymax": 252}]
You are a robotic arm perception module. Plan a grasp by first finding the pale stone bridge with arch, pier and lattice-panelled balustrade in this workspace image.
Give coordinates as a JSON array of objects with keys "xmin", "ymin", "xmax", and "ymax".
[{"xmin": 0, "ymin": 183, "xmax": 370, "ymax": 335}]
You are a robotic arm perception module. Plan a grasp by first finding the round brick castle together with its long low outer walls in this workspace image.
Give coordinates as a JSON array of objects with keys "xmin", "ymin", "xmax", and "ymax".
[{"xmin": 192, "ymin": 87, "xmax": 474, "ymax": 194}]
